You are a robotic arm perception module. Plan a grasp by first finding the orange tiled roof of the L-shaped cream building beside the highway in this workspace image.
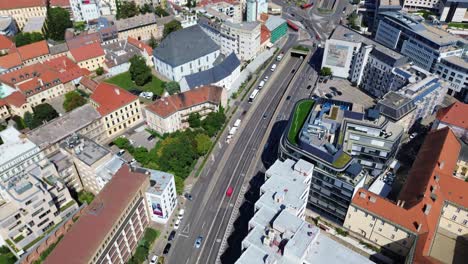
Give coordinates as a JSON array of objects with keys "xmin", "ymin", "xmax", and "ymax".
[{"xmin": 146, "ymin": 86, "xmax": 223, "ymax": 118}]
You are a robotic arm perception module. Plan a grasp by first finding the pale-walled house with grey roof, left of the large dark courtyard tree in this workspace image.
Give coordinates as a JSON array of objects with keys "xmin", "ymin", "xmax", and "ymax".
[{"xmin": 102, "ymin": 40, "xmax": 141, "ymax": 78}]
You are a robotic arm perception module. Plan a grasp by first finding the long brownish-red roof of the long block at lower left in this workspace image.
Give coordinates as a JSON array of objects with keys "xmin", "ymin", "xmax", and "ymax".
[{"xmin": 44, "ymin": 165, "xmax": 149, "ymax": 264}]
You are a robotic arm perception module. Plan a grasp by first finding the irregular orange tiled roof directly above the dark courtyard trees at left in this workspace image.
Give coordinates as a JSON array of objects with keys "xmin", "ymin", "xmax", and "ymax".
[{"xmin": 43, "ymin": 56, "xmax": 90, "ymax": 83}]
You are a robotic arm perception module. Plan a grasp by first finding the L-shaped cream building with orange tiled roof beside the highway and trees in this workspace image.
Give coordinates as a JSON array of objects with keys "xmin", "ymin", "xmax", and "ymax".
[{"xmin": 145, "ymin": 86, "xmax": 227, "ymax": 135}]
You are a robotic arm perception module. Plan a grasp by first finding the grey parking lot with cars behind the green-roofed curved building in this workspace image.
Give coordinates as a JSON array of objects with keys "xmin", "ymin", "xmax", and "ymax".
[{"xmin": 314, "ymin": 79, "xmax": 375, "ymax": 108}]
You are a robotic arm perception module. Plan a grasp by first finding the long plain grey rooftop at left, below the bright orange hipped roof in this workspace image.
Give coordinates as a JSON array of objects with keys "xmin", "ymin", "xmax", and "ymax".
[{"xmin": 27, "ymin": 104, "xmax": 101, "ymax": 148}]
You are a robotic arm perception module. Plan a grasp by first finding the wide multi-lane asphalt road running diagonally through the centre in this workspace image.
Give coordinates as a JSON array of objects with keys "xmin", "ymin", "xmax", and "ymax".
[{"xmin": 163, "ymin": 35, "xmax": 301, "ymax": 264}]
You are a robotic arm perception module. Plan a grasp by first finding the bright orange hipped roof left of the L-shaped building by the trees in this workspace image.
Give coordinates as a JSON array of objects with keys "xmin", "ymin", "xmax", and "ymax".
[{"xmin": 91, "ymin": 83, "xmax": 138, "ymax": 116}]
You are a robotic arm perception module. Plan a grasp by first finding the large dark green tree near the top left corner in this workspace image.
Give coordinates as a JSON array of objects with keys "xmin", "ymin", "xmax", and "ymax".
[{"xmin": 46, "ymin": 7, "xmax": 73, "ymax": 40}]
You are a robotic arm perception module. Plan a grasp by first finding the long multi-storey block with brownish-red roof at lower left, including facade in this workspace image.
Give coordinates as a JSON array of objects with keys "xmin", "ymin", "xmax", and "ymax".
[{"xmin": 44, "ymin": 165, "xmax": 149, "ymax": 264}]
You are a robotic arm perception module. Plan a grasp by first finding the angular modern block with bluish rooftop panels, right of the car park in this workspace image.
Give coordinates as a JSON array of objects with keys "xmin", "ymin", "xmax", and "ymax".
[{"xmin": 377, "ymin": 65, "xmax": 447, "ymax": 131}]
